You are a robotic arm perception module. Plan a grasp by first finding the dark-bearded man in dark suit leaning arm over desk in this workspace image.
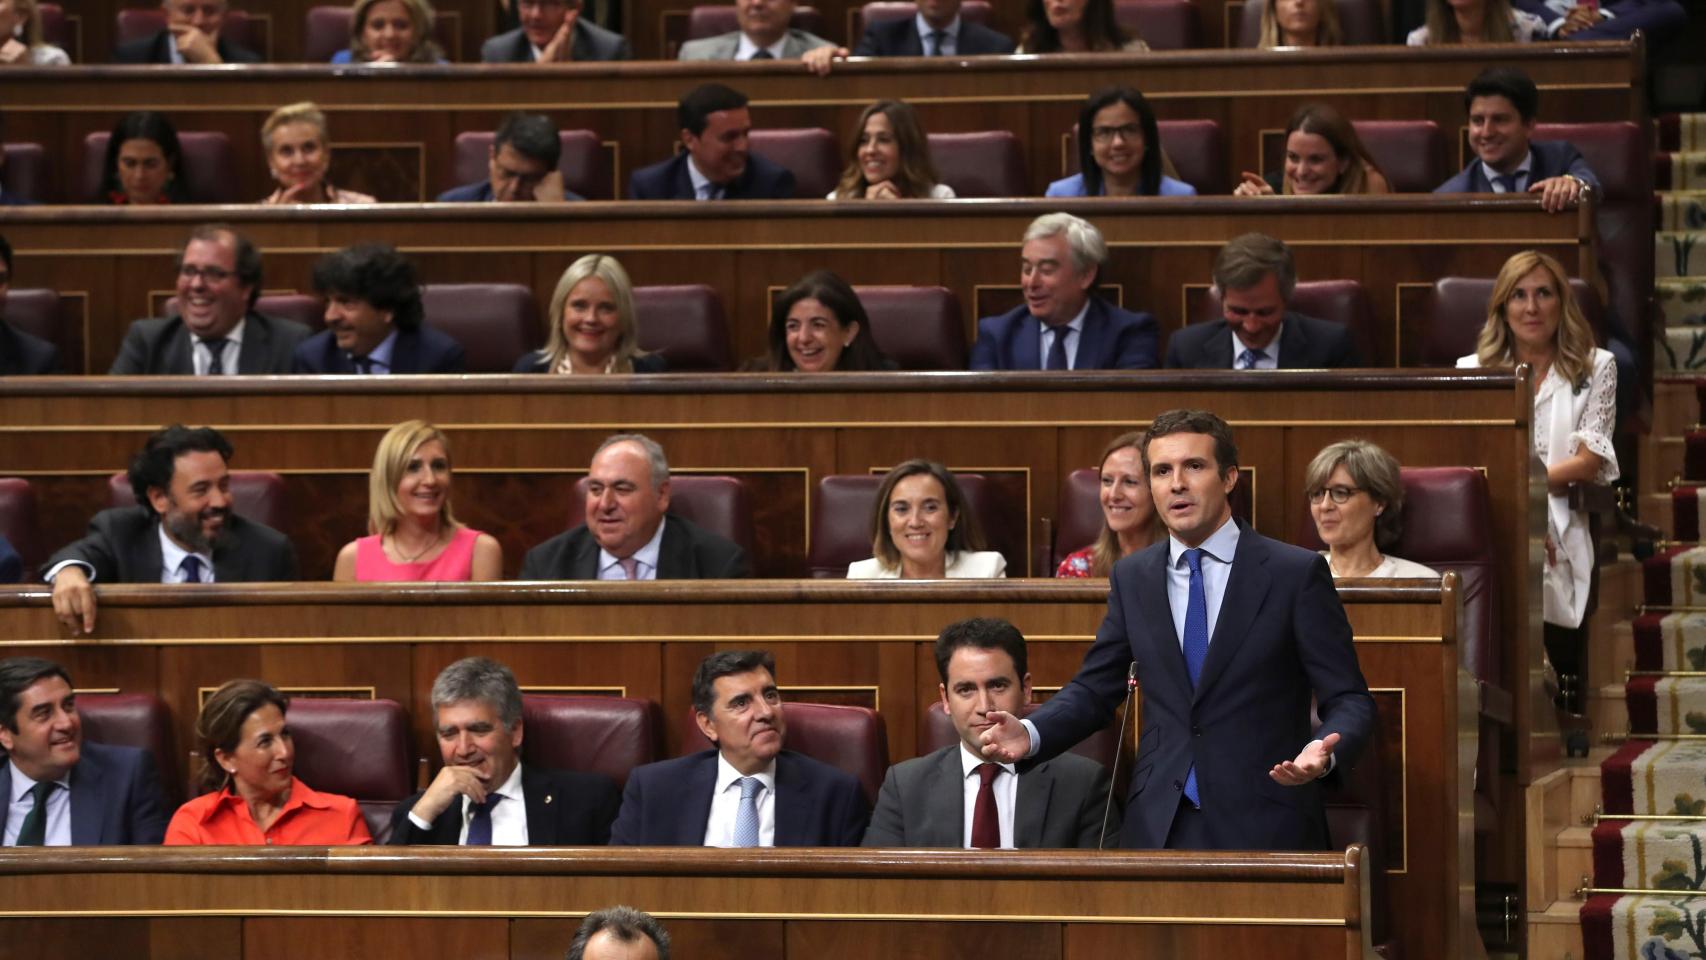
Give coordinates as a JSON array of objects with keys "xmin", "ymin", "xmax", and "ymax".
[{"xmin": 43, "ymin": 425, "xmax": 297, "ymax": 636}]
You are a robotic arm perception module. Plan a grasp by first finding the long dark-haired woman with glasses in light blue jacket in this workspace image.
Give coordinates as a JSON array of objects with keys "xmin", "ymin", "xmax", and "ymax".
[{"xmin": 1044, "ymin": 87, "xmax": 1196, "ymax": 196}]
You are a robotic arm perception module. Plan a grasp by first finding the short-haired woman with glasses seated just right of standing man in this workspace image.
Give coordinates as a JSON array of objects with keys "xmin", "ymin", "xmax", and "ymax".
[{"xmin": 1303, "ymin": 440, "xmax": 1440, "ymax": 580}]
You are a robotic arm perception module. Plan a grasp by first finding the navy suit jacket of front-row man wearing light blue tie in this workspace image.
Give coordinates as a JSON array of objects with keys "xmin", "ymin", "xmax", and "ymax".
[{"xmin": 611, "ymin": 749, "xmax": 870, "ymax": 847}]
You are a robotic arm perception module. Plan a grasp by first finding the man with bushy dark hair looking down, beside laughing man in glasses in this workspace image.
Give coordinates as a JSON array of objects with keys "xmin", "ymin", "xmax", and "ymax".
[{"xmin": 292, "ymin": 244, "xmax": 467, "ymax": 375}]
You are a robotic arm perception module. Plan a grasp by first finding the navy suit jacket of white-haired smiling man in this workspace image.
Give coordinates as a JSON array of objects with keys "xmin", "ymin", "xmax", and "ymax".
[{"xmin": 971, "ymin": 297, "xmax": 1160, "ymax": 370}]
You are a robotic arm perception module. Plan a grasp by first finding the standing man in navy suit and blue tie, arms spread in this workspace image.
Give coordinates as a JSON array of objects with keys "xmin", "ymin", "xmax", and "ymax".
[{"xmin": 983, "ymin": 409, "xmax": 1375, "ymax": 849}]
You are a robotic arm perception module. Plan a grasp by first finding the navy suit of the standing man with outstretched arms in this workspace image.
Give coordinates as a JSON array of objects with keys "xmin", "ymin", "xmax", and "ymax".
[{"xmin": 1027, "ymin": 523, "xmax": 1375, "ymax": 849}]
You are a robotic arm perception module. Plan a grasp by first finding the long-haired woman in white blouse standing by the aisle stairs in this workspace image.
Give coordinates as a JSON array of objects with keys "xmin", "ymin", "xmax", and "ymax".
[{"xmin": 1457, "ymin": 251, "xmax": 1617, "ymax": 634}]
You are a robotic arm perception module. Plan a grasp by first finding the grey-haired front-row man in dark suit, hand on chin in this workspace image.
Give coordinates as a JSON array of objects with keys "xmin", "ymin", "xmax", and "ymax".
[{"xmin": 389, "ymin": 656, "xmax": 621, "ymax": 847}]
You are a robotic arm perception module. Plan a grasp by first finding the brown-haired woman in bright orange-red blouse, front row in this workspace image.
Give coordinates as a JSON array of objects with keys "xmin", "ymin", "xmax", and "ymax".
[{"xmin": 165, "ymin": 680, "xmax": 374, "ymax": 846}]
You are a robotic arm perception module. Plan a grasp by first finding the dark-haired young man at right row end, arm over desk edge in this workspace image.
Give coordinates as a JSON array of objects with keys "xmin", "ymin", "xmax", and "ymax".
[{"xmin": 1433, "ymin": 67, "xmax": 1599, "ymax": 213}]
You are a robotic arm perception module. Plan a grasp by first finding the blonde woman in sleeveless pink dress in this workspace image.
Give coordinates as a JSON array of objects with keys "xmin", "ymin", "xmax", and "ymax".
[{"xmin": 331, "ymin": 419, "xmax": 503, "ymax": 581}]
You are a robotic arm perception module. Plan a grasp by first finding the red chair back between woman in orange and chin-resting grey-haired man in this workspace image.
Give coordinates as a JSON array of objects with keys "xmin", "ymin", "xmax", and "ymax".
[{"xmin": 288, "ymin": 697, "xmax": 415, "ymax": 844}]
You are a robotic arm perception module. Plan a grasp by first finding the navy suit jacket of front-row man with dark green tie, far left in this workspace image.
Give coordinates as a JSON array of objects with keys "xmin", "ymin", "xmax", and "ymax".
[{"xmin": 0, "ymin": 740, "xmax": 167, "ymax": 847}]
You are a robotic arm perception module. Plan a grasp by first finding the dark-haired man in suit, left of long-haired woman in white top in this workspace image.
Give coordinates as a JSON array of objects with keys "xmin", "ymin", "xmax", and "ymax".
[{"xmin": 628, "ymin": 84, "xmax": 793, "ymax": 200}]
